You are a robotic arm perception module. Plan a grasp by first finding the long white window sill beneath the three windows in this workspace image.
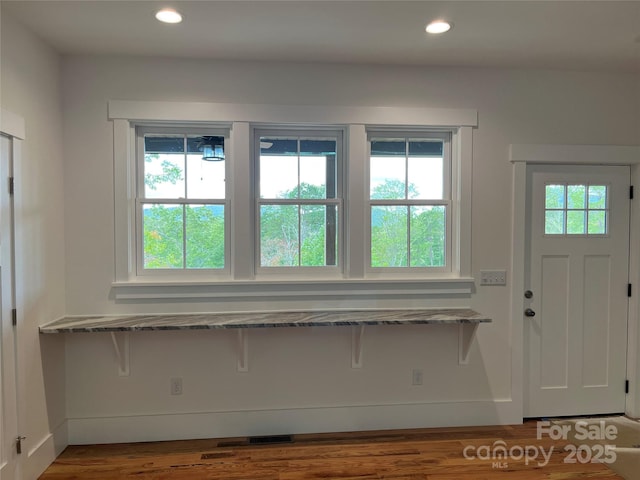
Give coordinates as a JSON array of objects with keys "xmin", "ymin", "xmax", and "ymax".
[{"xmin": 111, "ymin": 277, "xmax": 475, "ymax": 301}]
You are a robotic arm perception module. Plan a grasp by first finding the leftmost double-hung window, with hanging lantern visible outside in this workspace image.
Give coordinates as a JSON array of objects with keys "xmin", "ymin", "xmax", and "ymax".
[{"xmin": 136, "ymin": 128, "xmax": 228, "ymax": 274}]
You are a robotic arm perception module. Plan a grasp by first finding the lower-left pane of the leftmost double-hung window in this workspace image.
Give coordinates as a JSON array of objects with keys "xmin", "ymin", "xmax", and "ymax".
[{"xmin": 142, "ymin": 204, "xmax": 183, "ymax": 269}]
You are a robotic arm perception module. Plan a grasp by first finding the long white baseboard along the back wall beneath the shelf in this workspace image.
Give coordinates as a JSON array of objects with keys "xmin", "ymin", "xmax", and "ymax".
[{"xmin": 67, "ymin": 400, "xmax": 522, "ymax": 445}]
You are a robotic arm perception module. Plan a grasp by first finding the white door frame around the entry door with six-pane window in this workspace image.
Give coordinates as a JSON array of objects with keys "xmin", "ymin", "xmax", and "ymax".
[{"xmin": 509, "ymin": 144, "xmax": 640, "ymax": 418}]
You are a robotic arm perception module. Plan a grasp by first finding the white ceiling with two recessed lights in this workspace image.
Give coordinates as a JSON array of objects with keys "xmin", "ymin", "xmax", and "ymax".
[{"xmin": 0, "ymin": 0, "xmax": 640, "ymax": 73}]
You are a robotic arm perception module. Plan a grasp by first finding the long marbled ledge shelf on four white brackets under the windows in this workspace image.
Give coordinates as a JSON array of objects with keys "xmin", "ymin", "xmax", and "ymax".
[{"xmin": 40, "ymin": 308, "xmax": 491, "ymax": 376}]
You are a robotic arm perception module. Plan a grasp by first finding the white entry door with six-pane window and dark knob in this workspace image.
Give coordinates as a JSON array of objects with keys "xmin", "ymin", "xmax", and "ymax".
[{"xmin": 523, "ymin": 165, "xmax": 630, "ymax": 417}]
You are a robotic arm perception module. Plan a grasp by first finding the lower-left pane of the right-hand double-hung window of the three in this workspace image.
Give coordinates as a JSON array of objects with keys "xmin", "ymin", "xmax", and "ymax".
[{"xmin": 371, "ymin": 206, "xmax": 408, "ymax": 267}]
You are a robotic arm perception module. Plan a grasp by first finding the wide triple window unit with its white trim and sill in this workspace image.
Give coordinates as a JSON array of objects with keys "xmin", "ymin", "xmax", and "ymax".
[{"xmin": 109, "ymin": 101, "xmax": 477, "ymax": 301}]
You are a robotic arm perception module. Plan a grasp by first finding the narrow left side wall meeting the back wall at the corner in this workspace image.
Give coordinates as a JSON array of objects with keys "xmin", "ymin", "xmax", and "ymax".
[{"xmin": 0, "ymin": 7, "xmax": 67, "ymax": 478}]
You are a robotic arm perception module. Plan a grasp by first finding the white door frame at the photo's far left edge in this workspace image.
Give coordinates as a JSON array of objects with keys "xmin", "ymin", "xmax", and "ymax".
[{"xmin": 0, "ymin": 109, "xmax": 25, "ymax": 477}]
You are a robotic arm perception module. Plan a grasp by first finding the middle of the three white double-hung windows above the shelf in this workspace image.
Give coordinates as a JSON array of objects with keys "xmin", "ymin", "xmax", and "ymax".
[{"xmin": 254, "ymin": 130, "xmax": 342, "ymax": 270}]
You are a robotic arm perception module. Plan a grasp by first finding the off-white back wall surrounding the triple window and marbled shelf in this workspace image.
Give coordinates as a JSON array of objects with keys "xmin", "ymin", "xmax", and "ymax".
[{"xmin": 57, "ymin": 56, "xmax": 640, "ymax": 442}]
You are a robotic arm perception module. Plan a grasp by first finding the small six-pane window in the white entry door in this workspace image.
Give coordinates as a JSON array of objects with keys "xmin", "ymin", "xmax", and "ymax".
[{"xmin": 544, "ymin": 184, "xmax": 609, "ymax": 235}]
